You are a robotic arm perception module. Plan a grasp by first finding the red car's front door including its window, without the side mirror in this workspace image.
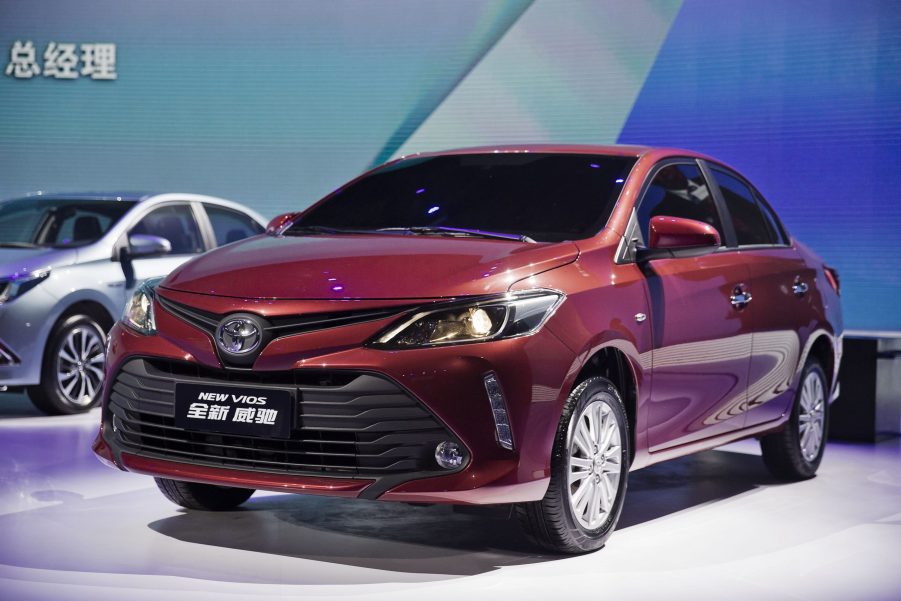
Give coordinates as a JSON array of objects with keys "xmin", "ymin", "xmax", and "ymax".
[{"xmin": 636, "ymin": 159, "xmax": 752, "ymax": 452}]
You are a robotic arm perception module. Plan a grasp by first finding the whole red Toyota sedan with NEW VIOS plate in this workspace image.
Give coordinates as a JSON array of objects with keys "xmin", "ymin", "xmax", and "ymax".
[{"xmin": 94, "ymin": 146, "xmax": 842, "ymax": 553}]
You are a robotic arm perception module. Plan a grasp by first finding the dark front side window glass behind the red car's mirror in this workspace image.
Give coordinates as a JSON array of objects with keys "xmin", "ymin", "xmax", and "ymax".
[{"xmin": 638, "ymin": 163, "xmax": 725, "ymax": 244}]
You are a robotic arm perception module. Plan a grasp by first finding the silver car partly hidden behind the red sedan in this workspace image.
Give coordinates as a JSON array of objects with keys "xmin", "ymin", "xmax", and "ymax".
[{"xmin": 0, "ymin": 194, "xmax": 266, "ymax": 414}]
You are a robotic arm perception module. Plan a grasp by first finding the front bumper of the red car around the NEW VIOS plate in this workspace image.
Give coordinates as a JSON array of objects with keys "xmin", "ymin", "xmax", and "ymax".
[{"xmin": 96, "ymin": 294, "xmax": 574, "ymax": 504}]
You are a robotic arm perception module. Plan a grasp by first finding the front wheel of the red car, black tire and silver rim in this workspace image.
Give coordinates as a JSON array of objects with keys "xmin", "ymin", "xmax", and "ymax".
[{"xmin": 515, "ymin": 378, "xmax": 631, "ymax": 554}]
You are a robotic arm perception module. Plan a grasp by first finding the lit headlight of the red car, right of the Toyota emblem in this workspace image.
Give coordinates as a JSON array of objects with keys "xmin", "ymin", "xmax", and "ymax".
[{"xmin": 371, "ymin": 290, "xmax": 565, "ymax": 349}]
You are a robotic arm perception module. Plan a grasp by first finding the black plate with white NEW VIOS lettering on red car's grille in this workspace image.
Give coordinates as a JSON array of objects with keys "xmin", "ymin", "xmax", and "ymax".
[{"xmin": 175, "ymin": 382, "xmax": 294, "ymax": 438}]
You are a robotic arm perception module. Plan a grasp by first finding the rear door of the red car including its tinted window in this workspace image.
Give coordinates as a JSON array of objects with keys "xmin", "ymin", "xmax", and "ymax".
[{"xmin": 707, "ymin": 163, "xmax": 804, "ymax": 426}]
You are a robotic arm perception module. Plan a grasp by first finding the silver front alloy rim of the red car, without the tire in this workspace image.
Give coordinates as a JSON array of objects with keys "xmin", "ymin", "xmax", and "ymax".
[{"xmin": 567, "ymin": 395, "xmax": 623, "ymax": 530}]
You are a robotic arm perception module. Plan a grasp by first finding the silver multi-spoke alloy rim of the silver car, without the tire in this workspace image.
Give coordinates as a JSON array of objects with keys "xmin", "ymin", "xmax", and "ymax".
[{"xmin": 56, "ymin": 326, "xmax": 105, "ymax": 407}]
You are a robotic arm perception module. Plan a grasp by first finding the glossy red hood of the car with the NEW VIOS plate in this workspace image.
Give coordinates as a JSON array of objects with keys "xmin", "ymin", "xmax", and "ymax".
[{"xmin": 162, "ymin": 234, "xmax": 579, "ymax": 299}]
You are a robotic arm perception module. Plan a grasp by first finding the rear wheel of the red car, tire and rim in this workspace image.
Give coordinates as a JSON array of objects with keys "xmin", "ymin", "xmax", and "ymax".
[{"xmin": 760, "ymin": 359, "xmax": 829, "ymax": 481}]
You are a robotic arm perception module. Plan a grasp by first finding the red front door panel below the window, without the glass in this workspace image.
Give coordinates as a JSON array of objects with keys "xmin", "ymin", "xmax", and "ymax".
[{"xmin": 646, "ymin": 252, "xmax": 752, "ymax": 452}]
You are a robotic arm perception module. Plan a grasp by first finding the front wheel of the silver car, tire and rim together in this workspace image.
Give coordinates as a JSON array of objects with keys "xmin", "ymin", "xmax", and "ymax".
[{"xmin": 27, "ymin": 314, "xmax": 106, "ymax": 415}]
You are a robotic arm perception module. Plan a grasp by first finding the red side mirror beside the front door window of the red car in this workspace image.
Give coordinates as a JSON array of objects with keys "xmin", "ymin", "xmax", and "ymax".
[{"xmin": 635, "ymin": 215, "xmax": 721, "ymax": 262}]
